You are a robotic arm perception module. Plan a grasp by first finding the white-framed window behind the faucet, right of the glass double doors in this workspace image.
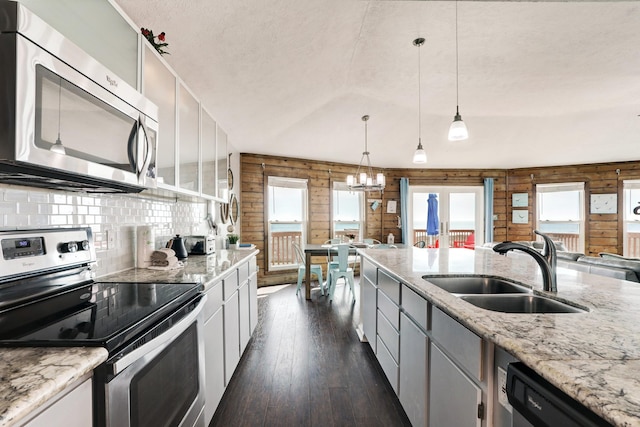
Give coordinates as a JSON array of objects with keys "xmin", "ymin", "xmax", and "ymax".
[{"xmin": 536, "ymin": 182, "xmax": 584, "ymax": 252}]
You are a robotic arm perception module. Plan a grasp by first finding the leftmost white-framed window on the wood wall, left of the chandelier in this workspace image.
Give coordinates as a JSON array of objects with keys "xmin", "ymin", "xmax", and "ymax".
[{"xmin": 267, "ymin": 176, "xmax": 307, "ymax": 271}]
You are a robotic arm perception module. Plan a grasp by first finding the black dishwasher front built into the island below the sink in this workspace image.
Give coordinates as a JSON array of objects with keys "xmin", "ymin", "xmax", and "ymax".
[{"xmin": 507, "ymin": 362, "xmax": 611, "ymax": 427}]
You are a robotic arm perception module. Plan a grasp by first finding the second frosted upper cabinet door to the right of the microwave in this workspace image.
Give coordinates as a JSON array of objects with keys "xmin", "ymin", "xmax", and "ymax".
[{"xmin": 178, "ymin": 83, "xmax": 200, "ymax": 193}]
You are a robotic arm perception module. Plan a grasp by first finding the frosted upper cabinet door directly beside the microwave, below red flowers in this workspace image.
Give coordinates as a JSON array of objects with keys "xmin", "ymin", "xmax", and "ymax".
[{"xmin": 142, "ymin": 43, "xmax": 177, "ymax": 186}]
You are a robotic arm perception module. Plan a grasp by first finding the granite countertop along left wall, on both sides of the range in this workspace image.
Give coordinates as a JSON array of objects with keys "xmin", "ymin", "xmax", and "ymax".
[{"xmin": 0, "ymin": 248, "xmax": 258, "ymax": 427}]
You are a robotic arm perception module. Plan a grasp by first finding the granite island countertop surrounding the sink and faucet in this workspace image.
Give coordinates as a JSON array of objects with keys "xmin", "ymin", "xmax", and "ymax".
[{"xmin": 359, "ymin": 248, "xmax": 640, "ymax": 426}]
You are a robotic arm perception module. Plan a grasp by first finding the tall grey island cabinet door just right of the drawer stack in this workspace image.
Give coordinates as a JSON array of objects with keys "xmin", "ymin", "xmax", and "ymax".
[{"xmin": 398, "ymin": 310, "xmax": 428, "ymax": 427}]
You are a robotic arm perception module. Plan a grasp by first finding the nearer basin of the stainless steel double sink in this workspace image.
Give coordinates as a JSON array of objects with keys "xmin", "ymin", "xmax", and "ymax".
[{"xmin": 460, "ymin": 294, "xmax": 586, "ymax": 313}]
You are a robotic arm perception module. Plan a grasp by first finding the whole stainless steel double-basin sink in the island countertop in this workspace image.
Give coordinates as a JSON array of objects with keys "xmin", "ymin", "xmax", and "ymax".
[{"xmin": 422, "ymin": 275, "xmax": 585, "ymax": 314}]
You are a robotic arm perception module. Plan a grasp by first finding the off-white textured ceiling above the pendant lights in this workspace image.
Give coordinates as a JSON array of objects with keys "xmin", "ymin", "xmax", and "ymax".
[{"xmin": 115, "ymin": 0, "xmax": 640, "ymax": 168}]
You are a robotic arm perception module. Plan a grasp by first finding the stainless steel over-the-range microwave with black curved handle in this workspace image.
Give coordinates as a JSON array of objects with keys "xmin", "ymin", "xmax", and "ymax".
[{"xmin": 0, "ymin": 0, "xmax": 158, "ymax": 192}]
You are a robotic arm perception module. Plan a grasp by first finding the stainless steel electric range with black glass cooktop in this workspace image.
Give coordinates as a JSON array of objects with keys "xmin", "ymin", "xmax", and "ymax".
[{"xmin": 0, "ymin": 227, "xmax": 206, "ymax": 427}]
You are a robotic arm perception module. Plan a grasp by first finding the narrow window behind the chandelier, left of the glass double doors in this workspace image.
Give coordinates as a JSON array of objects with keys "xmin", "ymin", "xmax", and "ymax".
[{"xmin": 331, "ymin": 182, "xmax": 367, "ymax": 241}]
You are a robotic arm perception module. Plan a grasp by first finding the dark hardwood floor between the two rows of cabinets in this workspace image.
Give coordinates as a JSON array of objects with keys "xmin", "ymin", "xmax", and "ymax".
[{"xmin": 210, "ymin": 285, "xmax": 411, "ymax": 427}]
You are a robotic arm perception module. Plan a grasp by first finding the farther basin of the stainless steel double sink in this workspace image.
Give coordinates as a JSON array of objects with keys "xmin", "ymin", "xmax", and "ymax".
[{"xmin": 422, "ymin": 276, "xmax": 531, "ymax": 294}]
